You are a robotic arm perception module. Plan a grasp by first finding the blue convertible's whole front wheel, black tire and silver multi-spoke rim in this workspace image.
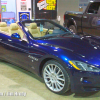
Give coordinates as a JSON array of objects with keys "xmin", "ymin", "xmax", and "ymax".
[{"xmin": 42, "ymin": 60, "xmax": 70, "ymax": 94}]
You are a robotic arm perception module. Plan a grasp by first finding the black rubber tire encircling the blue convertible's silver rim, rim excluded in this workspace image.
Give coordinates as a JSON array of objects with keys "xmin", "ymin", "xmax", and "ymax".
[{"xmin": 42, "ymin": 60, "xmax": 70, "ymax": 94}]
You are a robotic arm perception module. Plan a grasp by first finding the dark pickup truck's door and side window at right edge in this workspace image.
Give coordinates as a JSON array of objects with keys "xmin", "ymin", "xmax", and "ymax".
[{"xmin": 82, "ymin": 2, "xmax": 100, "ymax": 36}]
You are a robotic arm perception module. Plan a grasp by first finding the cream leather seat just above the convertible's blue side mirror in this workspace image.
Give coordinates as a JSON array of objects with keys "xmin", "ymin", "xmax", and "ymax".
[{"xmin": 9, "ymin": 23, "xmax": 24, "ymax": 38}]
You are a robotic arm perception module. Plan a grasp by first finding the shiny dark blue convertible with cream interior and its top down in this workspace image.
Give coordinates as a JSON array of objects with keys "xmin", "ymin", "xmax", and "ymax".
[{"xmin": 0, "ymin": 19, "xmax": 100, "ymax": 94}]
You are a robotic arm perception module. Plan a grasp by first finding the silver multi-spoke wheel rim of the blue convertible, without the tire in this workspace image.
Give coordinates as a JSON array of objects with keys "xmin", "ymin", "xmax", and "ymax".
[{"xmin": 43, "ymin": 64, "xmax": 65, "ymax": 92}]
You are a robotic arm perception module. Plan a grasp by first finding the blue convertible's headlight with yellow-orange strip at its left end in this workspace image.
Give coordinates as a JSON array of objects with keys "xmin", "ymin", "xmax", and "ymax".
[{"xmin": 69, "ymin": 61, "xmax": 100, "ymax": 72}]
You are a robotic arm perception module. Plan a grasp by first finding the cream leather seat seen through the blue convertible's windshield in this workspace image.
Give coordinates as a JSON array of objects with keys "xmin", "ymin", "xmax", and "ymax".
[{"xmin": 29, "ymin": 23, "xmax": 41, "ymax": 37}]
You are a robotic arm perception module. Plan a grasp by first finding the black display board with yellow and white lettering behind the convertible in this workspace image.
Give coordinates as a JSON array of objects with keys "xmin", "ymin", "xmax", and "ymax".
[{"xmin": 35, "ymin": 0, "xmax": 57, "ymax": 19}]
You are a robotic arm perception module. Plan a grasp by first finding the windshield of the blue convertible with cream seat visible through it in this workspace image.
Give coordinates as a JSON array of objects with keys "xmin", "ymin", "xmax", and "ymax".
[{"xmin": 23, "ymin": 20, "xmax": 72, "ymax": 39}]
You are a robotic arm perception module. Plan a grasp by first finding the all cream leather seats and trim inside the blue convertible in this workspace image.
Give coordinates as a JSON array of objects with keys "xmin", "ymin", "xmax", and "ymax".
[{"xmin": 0, "ymin": 22, "xmax": 53, "ymax": 38}]
